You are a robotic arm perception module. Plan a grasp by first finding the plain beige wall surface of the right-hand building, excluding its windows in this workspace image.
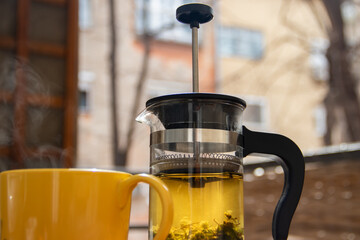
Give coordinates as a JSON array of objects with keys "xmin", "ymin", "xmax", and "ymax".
[{"xmin": 220, "ymin": 0, "xmax": 326, "ymax": 150}]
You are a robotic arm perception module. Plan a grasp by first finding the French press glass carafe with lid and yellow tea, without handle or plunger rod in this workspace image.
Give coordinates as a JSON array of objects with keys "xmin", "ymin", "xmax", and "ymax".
[{"xmin": 137, "ymin": 93, "xmax": 302, "ymax": 240}]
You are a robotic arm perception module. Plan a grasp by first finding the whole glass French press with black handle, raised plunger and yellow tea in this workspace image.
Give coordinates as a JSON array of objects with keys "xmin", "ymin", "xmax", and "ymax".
[{"xmin": 137, "ymin": 4, "xmax": 304, "ymax": 240}]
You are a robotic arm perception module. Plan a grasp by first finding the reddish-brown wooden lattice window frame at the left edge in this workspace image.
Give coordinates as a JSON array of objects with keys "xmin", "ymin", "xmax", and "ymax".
[{"xmin": 0, "ymin": 0, "xmax": 79, "ymax": 168}]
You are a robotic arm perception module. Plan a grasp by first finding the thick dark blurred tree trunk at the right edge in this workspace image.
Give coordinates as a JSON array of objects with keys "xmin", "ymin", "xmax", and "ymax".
[{"xmin": 323, "ymin": 0, "xmax": 360, "ymax": 145}]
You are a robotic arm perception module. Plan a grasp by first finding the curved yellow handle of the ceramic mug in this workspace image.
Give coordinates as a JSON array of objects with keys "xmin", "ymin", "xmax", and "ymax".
[{"xmin": 118, "ymin": 173, "xmax": 174, "ymax": 240}]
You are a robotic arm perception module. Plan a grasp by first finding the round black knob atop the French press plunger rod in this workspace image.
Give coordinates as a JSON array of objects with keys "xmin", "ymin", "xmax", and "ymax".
[{"xmin": 176, "ymin": 3, "xmax": 214, "ymax": 28}]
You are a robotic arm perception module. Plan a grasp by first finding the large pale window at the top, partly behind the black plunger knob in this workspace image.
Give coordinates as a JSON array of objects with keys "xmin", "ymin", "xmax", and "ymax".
[{"xmin": 135, "ymin": 0, "xmax": 191, "ymax": 44}]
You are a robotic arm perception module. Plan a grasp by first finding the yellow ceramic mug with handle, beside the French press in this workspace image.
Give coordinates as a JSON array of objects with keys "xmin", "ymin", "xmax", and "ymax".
[{"xmin": 0, "ymin": 169, "xmax": 173, "ymax": 240}]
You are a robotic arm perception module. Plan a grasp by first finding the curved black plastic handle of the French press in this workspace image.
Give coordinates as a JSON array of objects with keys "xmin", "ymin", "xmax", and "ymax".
[{"xmin": 243, "ymin": 126, "xmax": 305, "ymax": 240}]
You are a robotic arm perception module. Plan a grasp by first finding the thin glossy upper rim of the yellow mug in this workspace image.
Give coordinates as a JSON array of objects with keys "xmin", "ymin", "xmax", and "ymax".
[{"xmin": 0, "ymin": 168, "xmax": 132, "ymax": 176}]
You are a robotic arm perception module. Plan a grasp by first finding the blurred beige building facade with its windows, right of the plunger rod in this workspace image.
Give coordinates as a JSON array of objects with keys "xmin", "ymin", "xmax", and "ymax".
[{"xmin": 218, "ymin": 0, "xmax": 328, "ymax": 150}]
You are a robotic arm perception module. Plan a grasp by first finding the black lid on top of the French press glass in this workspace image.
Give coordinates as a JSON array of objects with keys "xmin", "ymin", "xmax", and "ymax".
[{"xmin": 146, "ymin": 93, "xmax": 246, "ymax": 132}]
